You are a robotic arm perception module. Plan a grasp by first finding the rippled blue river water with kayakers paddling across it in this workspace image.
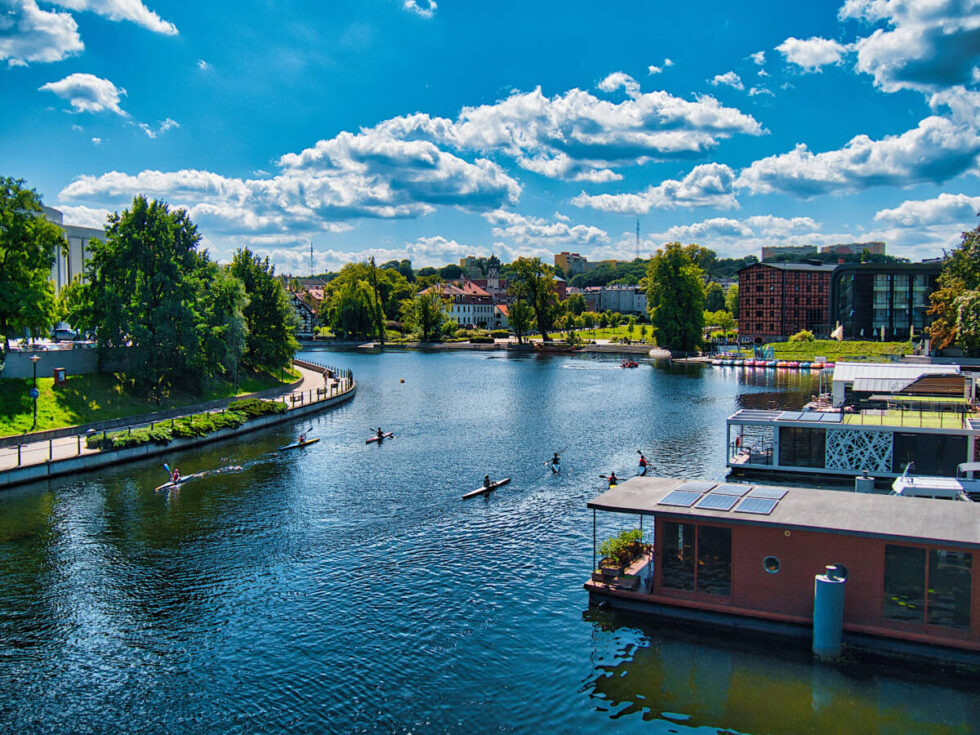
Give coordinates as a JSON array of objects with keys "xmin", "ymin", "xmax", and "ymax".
[{"xmin": 0, "ymin": 352, "xmax": 980, "ymax": 733}]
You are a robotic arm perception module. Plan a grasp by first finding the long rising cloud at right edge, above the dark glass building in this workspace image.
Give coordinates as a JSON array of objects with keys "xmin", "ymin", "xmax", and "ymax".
[{"xmin": 737, "ymin": 116, "xmax": 980, "ymax": 196}]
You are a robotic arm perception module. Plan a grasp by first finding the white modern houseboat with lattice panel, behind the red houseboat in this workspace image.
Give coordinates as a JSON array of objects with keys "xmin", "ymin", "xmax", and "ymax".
[{"xmin": 727, "ymin": 363, "xmax": 980, "ymax": 479}]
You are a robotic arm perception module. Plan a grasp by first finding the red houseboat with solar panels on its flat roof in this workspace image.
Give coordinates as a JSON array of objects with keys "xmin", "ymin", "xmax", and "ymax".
[{"xmin": 585, "ymin": 477, "xmax": 980, "ymax": 667}]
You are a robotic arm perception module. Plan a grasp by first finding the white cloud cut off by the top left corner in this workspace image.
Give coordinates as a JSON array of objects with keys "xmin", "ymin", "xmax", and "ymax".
[{"xmin": 0, "ymin": 0, "xmax": 85, "ymax": 66}]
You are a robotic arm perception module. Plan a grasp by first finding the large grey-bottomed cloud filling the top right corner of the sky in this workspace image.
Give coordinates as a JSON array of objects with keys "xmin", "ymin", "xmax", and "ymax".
[{"xmin": 838, "ymin": 0, "xmax": 980, "ymax": 92}]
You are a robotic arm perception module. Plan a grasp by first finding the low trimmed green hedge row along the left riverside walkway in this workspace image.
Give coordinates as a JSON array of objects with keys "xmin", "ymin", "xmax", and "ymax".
[{"xmin": 85, "ymin": 398, "xmax": 286, "ymax": 451}]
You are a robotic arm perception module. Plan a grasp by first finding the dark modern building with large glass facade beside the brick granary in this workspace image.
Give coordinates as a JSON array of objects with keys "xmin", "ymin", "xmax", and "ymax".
[{"xmin": 830, "ymin": 260, "xmax": 942, "ymax": 340}]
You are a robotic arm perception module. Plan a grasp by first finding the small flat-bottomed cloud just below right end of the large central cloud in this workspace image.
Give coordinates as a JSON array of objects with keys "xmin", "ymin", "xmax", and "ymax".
[{"xmin": 572, "ymin": 163, "xmax": 738, "ymax": 214}]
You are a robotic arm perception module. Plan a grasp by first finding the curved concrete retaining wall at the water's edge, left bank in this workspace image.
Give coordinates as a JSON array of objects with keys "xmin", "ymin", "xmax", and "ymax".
[{"xmin": 0, "ymin": 383, "xmax": 357, "ymax": 488}]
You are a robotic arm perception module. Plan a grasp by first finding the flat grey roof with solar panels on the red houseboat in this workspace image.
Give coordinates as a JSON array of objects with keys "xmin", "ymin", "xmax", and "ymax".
[{"xmin": 588, "ymin": 477, "xmax": 980, "ymax": 548}]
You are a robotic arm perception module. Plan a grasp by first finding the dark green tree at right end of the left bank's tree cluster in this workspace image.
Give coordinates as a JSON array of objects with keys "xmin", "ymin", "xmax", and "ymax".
[{"xmin": 231, "ymin": 248, "xmax": 299, "ymax": 372}]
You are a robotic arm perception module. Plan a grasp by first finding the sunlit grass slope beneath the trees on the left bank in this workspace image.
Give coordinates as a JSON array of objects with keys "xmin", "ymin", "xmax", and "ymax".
[{"xmin": 0, "ymin": 372, "xmax": 299, "ymax": 436}]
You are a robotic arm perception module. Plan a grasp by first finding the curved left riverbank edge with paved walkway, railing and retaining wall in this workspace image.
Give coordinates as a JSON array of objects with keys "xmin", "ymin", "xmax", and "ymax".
[{"xmin": 0, "ymin": 360, "xmax": 357, "ymax": 489}]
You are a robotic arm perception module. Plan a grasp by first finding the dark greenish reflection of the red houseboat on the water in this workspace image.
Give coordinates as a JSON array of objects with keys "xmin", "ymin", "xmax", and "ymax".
[{"xmin": 583, "ymin": 608, "xmax": 980, "ymax": 734}]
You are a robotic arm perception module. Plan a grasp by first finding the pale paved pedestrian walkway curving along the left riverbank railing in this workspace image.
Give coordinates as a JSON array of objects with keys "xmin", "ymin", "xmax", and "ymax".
[{"xmin": 0, "ymin": 363, "xmax": 344, "ymax": 472}]
